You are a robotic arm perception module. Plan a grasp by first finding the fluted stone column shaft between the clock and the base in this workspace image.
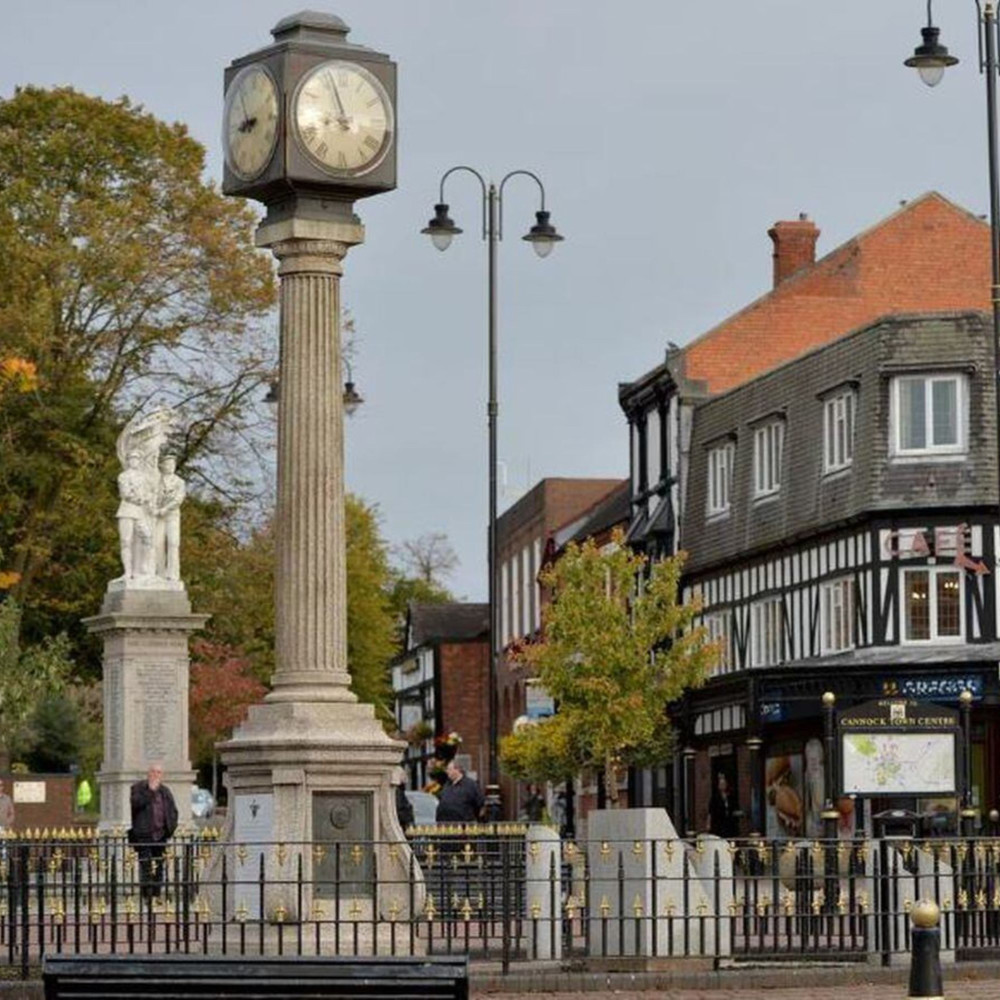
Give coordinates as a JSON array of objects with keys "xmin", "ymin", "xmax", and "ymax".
[{"xmin": 268, "ymin": 239, "xmax": 354, "ymax": 701}]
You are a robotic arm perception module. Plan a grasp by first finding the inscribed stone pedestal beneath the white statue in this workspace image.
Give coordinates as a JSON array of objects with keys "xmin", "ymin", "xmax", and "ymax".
[{"xmin": 83, "ymin": 581, "xmax": 209, "ymax": 830}]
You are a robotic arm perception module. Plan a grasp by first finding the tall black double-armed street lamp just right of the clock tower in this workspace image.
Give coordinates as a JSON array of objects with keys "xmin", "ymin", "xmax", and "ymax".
[{"xmin": 421, "ymin": 166, "xmax": 563, "ymax": 820}]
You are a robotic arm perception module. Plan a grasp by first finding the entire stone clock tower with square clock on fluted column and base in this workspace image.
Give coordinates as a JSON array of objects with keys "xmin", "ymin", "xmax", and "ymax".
[{"xmin": 219, "ymin": 11, "xmax": 423, "ymax": 927}]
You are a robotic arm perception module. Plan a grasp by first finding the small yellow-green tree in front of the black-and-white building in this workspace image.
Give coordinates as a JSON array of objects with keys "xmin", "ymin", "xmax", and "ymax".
[{"xmin": 500, "ymin": 532, "xmax": 718, "ymax": 799}]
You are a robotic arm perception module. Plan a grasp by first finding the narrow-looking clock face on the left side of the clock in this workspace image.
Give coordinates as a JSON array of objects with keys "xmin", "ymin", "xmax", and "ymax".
[{"xmin": 222, "ymin": 66, "xmax": 279, "ymax": 181}]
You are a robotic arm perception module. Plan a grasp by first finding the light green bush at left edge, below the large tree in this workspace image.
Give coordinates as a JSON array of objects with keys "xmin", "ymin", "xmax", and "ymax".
[{"xmin": 0, "ymin": 599, "xmax": 73, "ymax": 756}]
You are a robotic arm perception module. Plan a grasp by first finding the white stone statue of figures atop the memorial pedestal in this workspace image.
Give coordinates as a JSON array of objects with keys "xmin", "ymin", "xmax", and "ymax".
[{"xmin": 112, "ymin": 409, "xmax": 186, "ymax": 588}]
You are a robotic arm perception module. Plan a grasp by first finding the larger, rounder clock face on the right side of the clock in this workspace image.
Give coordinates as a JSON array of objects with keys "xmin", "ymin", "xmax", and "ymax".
[{"xmin": 292, "ymin": 60, "xmax": 393, "ymax": 177}]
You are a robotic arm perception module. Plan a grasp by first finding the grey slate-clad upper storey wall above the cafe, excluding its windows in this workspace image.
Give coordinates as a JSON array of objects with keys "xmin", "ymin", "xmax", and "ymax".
[{"xmin": 681, "ymin": 312, "xmax": 997, "ymax": 573}]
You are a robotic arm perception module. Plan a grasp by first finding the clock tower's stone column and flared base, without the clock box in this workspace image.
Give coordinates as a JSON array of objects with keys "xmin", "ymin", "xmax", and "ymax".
[{"xmin": 219, "ymin": 215, "xmax": 422, "ymax": 920}]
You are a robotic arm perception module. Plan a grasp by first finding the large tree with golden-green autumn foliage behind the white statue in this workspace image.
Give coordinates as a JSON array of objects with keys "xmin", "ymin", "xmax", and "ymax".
[{"xmin": 0, "ymin": 87, "xmax": 275, "ymax": 648}]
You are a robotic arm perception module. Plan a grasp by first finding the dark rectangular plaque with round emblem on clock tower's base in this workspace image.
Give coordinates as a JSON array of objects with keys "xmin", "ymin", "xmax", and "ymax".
[{"xmin": 313, "ymin": 792, "xmax": 375, "ymax": 899}]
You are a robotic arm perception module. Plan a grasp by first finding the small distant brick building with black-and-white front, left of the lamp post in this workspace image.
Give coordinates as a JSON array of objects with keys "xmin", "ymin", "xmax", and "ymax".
[{"xmin": 392, "ymin": 603, "xmax": 490, "ymax": 789}]
